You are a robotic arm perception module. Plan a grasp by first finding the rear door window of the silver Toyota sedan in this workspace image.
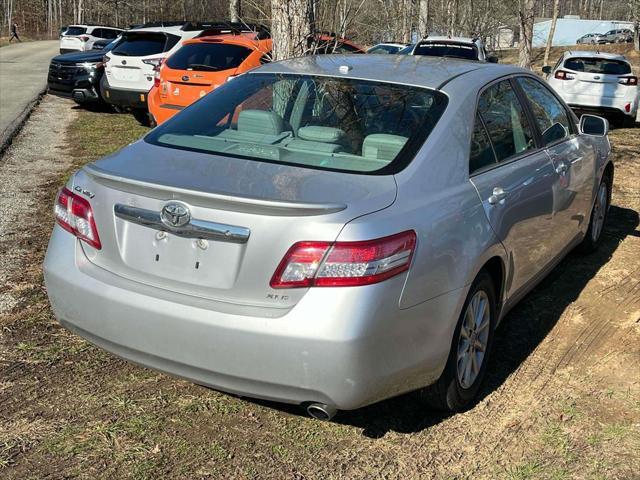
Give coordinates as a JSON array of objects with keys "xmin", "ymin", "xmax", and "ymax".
[{"xmin": 478, "ymin": 80, "xmax": 535, "ymax": 162}]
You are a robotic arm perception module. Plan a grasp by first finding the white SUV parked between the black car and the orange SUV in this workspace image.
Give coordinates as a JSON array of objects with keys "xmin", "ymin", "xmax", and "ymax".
[{"xmin": 100, "ymin": 22, "xmax": 214, "ymax": 119}]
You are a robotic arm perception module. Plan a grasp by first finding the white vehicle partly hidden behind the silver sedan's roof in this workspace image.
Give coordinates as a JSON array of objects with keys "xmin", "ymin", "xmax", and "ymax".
[{"xmin": 408, "ymin": 36, "xmax": 498, "ymax": 63}]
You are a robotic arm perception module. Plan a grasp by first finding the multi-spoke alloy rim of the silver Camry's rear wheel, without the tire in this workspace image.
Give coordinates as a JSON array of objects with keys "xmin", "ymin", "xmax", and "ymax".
[{"xmin": 456, "ymin": 290, "xmax": 491, "ymax": 388}]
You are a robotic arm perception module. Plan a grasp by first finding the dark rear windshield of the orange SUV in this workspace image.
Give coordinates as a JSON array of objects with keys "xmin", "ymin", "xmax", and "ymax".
[{"xmin": 167, "ymin": 43, "xmax": 252, "ymax": 72}]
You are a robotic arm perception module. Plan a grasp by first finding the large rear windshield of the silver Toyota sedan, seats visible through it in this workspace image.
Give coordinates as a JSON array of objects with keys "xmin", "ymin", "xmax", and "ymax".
[{"xmin": 145, "ymin": 73, "xmax": 447, "ymax": 174}]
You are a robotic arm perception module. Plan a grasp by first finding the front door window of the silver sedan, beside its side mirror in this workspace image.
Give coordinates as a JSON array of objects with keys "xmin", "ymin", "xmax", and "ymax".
[{"xmin": 518, "ymin": 77, "xmax": 571, "ymax": 145}]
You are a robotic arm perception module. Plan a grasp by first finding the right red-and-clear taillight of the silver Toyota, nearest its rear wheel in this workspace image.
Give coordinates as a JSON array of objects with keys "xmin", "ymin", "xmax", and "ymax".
[{"xmin": 270, "ymin": 230, "xmax": 416, "ymax": 288}]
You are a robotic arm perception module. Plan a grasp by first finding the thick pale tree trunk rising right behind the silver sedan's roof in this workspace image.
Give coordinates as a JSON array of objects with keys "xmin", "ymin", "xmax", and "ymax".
[{"xmin": 271, "ymin": 0, "xmax": 314, "ymax": 60}]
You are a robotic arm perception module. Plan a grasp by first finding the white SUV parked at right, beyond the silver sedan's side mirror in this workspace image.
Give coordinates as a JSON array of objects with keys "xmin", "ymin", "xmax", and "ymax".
[{"xmin": 543, "ymin": 51, "xmax": 639, "ymax": 127}]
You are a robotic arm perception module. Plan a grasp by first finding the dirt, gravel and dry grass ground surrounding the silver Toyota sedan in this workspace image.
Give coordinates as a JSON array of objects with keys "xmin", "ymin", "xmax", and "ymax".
[{"xmin": 0, "ymin": 70, "xmax": 640, "ymax": 480}]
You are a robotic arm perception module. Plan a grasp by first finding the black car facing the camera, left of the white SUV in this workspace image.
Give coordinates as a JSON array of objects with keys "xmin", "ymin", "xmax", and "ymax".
[{"xmin": 47, "ymin": 40, "xmax": 118, "ymax": 105}]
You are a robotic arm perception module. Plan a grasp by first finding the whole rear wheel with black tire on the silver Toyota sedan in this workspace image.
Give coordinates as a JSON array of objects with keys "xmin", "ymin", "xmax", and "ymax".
[{"xmin": 420, "ymin": 271, "xmax": 497, "ymax": 412}]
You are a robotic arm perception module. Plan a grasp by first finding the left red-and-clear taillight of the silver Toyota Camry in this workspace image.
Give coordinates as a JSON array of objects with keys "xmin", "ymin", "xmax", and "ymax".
[{"xmin": 54, "ymin": 187, "xmax": 102, "ymax": 250}]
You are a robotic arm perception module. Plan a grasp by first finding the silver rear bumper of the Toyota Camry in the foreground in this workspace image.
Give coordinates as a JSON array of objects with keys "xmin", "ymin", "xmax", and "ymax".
[{"xmin": 44, "ymin": 226, "xmax": 465, "ymax": 410}]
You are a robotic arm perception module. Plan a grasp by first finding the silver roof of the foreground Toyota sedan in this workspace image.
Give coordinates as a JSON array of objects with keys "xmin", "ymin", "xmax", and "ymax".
[{"xmin": 251, "ymin": 54, "xmax": 520, "ymax": 88}]
